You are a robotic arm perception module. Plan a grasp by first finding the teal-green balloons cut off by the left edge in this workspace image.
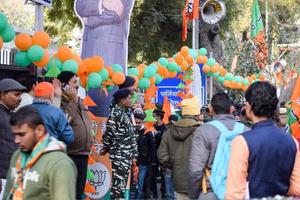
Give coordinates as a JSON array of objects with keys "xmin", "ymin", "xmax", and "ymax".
[{"xmin": 0, "ymin": 12, "xmax": 15, "ymax": 49}]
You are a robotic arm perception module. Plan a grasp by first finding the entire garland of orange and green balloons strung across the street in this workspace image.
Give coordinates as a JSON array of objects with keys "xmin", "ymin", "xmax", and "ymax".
[{"xmin": 0, "ymin": 9, "xmax": 264, "ymax": 93}]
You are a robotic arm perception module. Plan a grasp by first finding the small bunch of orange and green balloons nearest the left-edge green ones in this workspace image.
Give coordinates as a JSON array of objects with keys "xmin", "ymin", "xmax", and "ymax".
[{"xmin": 15, "ymin": 32, "xmax": 50, "ymax": 67}]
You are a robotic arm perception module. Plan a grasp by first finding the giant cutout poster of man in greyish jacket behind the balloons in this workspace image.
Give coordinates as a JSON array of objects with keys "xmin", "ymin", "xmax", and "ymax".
[{"xmin": 74, "ymin": 0, "xmax": 134, "ymax": 117}]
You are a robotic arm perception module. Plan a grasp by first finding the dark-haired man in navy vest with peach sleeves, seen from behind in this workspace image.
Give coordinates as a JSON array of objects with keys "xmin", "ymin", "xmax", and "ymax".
[{"xmin": 226, "ymin": 82, "xmax": 300, "ymax": 199}]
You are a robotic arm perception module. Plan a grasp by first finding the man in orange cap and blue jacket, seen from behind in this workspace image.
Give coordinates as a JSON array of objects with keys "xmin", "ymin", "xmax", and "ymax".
[{"xmin": 32, "ymin": 82, "xmax": 74, "ymax": 144}]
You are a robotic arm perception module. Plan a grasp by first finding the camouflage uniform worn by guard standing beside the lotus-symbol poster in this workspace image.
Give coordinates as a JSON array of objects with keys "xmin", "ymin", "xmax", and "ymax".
[{"xmin": 103, "ymin": 103, "xmax": 138, "ymax": 199}]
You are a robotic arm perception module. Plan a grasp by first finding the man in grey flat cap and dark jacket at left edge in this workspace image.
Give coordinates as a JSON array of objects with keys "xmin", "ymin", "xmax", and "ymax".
[{"xmin": 0, "ymin": 78, "xmax": 26, "ymax": 199}]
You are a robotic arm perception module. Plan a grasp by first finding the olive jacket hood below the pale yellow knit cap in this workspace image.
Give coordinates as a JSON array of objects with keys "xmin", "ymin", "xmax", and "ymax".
[{"xmin": 170, "ymin": 117, "xmax": 201, "ymax": 141}]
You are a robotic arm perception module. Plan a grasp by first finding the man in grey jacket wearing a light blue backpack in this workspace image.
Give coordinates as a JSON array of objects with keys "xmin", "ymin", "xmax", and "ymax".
[{"xmin": 189, "ymin": 93, "xmax": 249, "ymax": 199}]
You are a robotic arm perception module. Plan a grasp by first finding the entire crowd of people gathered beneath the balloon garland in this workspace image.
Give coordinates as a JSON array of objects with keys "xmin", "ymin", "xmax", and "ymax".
[{"xmin": 0, "ymin": 72, "xmax": 300, "ymax": 200}]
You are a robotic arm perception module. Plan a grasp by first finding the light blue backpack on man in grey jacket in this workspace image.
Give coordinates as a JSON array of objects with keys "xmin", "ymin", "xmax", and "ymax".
[{"xmin": 209, "ymin": 120, "xmax": 244, "ymax": 199}]
